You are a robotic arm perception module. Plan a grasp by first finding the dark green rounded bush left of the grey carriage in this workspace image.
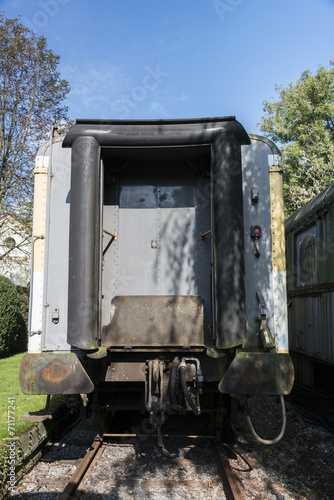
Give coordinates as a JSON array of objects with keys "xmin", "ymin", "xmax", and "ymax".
[{"xmin": 0, "ymin": 276, "xmax": 27, "ymax": 357}]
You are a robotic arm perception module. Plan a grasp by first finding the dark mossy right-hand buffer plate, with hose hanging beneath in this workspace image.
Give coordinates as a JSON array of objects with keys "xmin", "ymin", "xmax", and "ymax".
[{"xmin": 218, "ymin": 351, "xmax": 294, "ymax": 395}]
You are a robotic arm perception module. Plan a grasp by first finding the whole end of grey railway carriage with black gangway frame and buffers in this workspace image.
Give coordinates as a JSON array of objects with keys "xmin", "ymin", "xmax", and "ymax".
[{"xmin": 20, "ymin": 117, "xmax": 293, "ymax": 434}]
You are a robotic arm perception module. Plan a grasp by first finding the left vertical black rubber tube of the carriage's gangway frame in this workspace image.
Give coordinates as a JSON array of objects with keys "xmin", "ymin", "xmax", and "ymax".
[{"xmin": 67, "ymin": 136, "xmax": 100, "ymax": 349}]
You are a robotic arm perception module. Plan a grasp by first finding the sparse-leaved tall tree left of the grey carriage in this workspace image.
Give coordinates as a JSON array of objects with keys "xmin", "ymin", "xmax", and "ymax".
[{"xmin": 0, "ymin": 12, "xmax": 69, "ymax": 222}]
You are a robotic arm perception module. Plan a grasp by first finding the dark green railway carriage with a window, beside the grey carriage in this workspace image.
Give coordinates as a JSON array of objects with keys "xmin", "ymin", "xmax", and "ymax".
[{"xmin": 285, "ymin": 183, "xmax": 334, "ymax": 392}]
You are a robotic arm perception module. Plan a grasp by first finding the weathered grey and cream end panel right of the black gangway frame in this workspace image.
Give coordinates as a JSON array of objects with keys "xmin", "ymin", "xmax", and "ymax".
[{"xmin": 242, "ymin": 135, "xmax": 288, "ymax": 352}]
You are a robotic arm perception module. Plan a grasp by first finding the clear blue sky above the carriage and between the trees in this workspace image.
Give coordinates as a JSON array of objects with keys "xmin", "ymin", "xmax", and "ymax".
[{"xmin": 0, "ymin": 0, "xmax": 334, "ymax": 133}]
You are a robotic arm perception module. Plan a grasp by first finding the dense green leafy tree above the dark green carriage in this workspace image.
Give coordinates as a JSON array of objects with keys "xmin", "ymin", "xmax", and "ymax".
[{"xmin": 260, "ymin": 60, "xmax": 334, "ymax": 216}]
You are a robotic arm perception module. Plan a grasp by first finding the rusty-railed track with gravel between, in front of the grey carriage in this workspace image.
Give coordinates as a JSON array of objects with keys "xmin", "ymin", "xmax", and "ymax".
[{"xmin": 60, "ymin": 434, "xmax": 243, "ymax": 500}]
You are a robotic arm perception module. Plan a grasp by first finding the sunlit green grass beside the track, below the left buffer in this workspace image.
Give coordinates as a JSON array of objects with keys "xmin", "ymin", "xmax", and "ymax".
[{"xmin": 0, "ymin": 353, "xmax": 64, "ymax": 445}]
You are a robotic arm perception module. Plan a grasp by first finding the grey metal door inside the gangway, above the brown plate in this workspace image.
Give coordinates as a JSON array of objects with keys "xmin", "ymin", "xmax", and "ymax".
[{"xmin": 118, "ymin": 185, "xmax": 198, "ymax": 295}]
